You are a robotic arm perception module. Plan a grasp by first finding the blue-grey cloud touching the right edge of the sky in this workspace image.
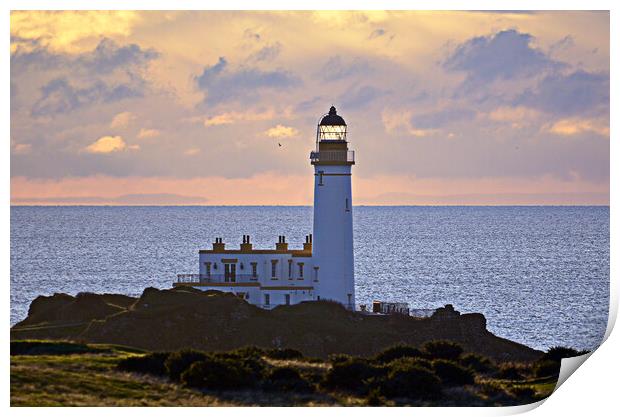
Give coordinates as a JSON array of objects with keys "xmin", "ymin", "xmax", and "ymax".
[{"xmin": 515, "ymin": 70, "xmax": 609, "ymax": 115}]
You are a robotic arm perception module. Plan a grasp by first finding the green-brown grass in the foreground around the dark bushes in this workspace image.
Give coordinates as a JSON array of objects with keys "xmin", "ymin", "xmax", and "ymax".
[{"xmin": 10, "ymin": 341, "xmax": 557, "ymax": 406}]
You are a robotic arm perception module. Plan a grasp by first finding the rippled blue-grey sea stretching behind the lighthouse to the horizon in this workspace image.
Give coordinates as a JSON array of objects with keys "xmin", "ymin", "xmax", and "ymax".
[{"xmin": 10, "ymin": 206, "xmax": 609, "ymax": 350}]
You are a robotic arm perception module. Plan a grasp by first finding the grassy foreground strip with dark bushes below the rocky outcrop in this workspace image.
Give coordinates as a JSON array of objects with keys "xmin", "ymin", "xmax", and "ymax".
[{"xmin": 11, "ymin": 341, "xmax": 583, "ymax": 406}]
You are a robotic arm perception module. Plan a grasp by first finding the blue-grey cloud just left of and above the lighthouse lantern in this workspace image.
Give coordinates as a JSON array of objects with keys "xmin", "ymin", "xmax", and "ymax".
[{"xmin": 195, "ymin": 57, "xmax": 300, "ymax": 104}]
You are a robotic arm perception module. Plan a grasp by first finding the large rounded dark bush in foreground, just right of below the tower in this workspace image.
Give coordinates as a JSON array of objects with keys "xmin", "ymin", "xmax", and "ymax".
[{"xmin": 381, "ymin": 365, "xmax": 441, "ymax": 400}]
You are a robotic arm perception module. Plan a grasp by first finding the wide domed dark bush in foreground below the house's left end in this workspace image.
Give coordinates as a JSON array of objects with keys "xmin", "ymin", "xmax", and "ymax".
[{"xmin": 181, "ymin": 356, "xmax": 257, "ymax": 390}]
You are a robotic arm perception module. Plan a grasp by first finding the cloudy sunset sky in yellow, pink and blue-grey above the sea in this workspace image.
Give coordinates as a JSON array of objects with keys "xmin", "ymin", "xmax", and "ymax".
[{"xmin": 10, "ymin": 11, "xmax": 610, "ymax": 205}]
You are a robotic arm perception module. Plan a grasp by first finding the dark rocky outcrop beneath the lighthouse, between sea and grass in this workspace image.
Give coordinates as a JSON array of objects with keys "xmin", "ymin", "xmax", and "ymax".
[{"xmin": 11, "ymin": 287, "xmax": 541, "ymax": 361}]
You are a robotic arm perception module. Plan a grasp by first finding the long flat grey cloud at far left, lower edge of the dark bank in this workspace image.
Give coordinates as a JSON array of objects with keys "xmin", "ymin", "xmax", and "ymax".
[{"xmin": 31, "ymin": 78, "xmax": 143, "ymax": 117}]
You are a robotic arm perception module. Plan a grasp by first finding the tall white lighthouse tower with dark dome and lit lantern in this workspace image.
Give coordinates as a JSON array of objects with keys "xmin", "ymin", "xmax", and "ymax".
[{"xmin": 310, "ymin": 106, "xmax": 355, "ymax": 309}]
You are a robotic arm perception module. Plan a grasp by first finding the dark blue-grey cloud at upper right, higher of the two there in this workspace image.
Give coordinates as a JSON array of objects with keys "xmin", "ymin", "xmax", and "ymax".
[{"xmin": 443, "ymin": 29, "xmax": 564, "ymax": 85}]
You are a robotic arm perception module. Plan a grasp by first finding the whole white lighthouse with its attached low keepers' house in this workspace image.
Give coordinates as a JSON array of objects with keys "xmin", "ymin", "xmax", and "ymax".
[{"xmin": 173, "ymin": 106, "xmax": 355, "ymax": 309}]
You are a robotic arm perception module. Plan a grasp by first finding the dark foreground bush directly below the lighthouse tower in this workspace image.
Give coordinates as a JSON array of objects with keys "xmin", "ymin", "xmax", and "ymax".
[{"xmin": 323, "ymin": 358, "xmax": 385, "ymax": 393}]
